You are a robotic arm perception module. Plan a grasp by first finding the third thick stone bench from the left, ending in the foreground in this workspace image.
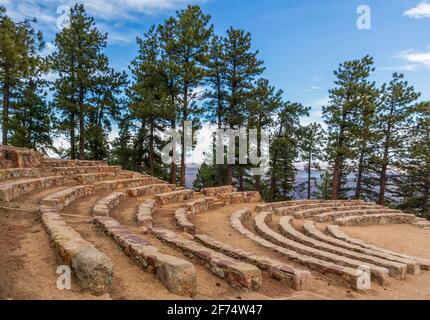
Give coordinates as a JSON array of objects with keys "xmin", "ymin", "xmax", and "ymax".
[{"xmin": 152, "ymin": 228, "xmax": 262, "ymax": 290}]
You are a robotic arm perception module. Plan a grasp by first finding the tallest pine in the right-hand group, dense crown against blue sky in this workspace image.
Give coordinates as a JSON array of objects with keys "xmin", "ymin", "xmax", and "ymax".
[{"xmin": 323, "ymin": 56, "xmax": 373, "ymax": 200}]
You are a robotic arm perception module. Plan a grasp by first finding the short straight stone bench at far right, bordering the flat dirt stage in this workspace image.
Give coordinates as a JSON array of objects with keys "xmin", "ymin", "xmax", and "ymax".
[{"xmin": 334, "ymin": 213, "xmax": 415, "ymax": 227}]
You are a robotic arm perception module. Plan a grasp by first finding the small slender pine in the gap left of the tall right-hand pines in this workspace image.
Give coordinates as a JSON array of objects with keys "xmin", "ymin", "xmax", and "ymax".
[{"xmin": 299, "ymin": 123, "xmax": 325, "ymax": 199}]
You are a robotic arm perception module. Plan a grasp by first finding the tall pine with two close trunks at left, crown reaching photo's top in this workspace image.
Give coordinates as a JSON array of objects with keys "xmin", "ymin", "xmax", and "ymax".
[{"xmin": 50, "ymin": 4, "xmax": 108, "ymax": 159}]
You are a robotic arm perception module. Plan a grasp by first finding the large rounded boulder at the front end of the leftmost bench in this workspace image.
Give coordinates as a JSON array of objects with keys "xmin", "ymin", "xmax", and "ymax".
[{"xmin": 72, "ymin": 247, "xmax": 113, "ymax": 295}]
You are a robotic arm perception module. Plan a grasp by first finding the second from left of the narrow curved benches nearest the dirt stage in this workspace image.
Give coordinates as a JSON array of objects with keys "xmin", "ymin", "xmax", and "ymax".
[{"xmin": 255, "ymin": 212, "xmax": 389, "ymax": 285}]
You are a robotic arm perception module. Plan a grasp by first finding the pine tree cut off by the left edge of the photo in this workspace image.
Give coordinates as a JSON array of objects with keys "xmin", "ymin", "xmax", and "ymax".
[{"xmin": 0, "ymin": 6, "xmax": 43, "ymax": 145}]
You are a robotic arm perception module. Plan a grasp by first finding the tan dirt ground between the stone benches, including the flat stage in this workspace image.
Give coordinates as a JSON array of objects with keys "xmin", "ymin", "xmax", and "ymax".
[{"xmin": 0, "ymin": 188, "xmax": 430, "ymax": 300}]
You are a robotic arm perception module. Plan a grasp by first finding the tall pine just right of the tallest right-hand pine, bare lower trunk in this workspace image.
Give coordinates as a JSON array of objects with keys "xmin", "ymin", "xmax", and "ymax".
[{"xmin": 377, "ymin": 73, "xmax": 420, "ymax": 205}]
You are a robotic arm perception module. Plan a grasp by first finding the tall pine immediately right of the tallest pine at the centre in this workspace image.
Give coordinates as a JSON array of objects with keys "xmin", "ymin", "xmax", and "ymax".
[{"xmin": 224, "ymin": 28, "xmax": 264, "ymax": 185}]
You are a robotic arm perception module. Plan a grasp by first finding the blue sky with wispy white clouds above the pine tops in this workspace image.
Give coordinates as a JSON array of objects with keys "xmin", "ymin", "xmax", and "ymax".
[{"xmin": 0, "ymin": 0, "xmax": 430, "ymax": 159}]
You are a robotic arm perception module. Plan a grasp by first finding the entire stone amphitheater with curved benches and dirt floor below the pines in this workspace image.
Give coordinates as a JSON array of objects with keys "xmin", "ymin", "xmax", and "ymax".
[{"xmin": 0, "ymin": 147, "xmax": 430, "ymax": 300}]
